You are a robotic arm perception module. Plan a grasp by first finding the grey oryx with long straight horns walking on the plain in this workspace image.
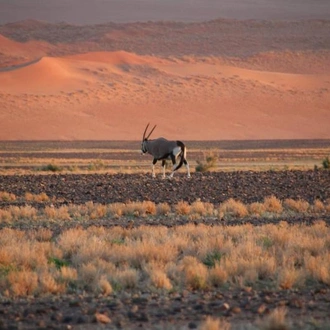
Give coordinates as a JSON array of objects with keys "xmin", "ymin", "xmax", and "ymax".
[{"xmin": 141, "ymin": 124, "xmax": 190, "ymax": 178}]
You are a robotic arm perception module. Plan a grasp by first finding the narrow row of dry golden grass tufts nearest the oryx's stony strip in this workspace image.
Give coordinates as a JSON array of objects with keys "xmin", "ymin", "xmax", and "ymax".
[{"xmin": 0, "ymin": 196, "xmax": 330, "ymax": 223}]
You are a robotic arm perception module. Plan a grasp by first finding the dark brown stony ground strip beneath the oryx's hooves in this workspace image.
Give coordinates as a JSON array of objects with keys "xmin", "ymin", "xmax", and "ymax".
[{"xmin": 0, "ymin": 170, "xmax": 330, "ymax": 207}]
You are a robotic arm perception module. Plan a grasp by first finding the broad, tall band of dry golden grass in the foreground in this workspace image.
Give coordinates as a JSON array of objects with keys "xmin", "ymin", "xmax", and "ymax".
[{"xmin": 0, "ymin": 217, "xmax": 330, "ymax": 296}]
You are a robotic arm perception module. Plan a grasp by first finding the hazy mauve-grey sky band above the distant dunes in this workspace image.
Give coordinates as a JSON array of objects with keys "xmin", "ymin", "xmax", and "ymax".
[{"xmin": 0, "ymin": 0, "xmax": 330, "ymax": 24}]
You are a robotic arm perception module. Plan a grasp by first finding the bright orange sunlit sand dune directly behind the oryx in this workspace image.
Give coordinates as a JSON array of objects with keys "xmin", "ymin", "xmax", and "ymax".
[{"xmin": 0, "ymin": 52, "xmax": 330, "ymax": 140}]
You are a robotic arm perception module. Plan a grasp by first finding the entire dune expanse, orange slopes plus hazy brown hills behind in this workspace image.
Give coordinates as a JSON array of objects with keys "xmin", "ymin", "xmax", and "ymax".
[{"xmin": 0, "ymin": 1, "xmax": 330, "ymax": 140}]
